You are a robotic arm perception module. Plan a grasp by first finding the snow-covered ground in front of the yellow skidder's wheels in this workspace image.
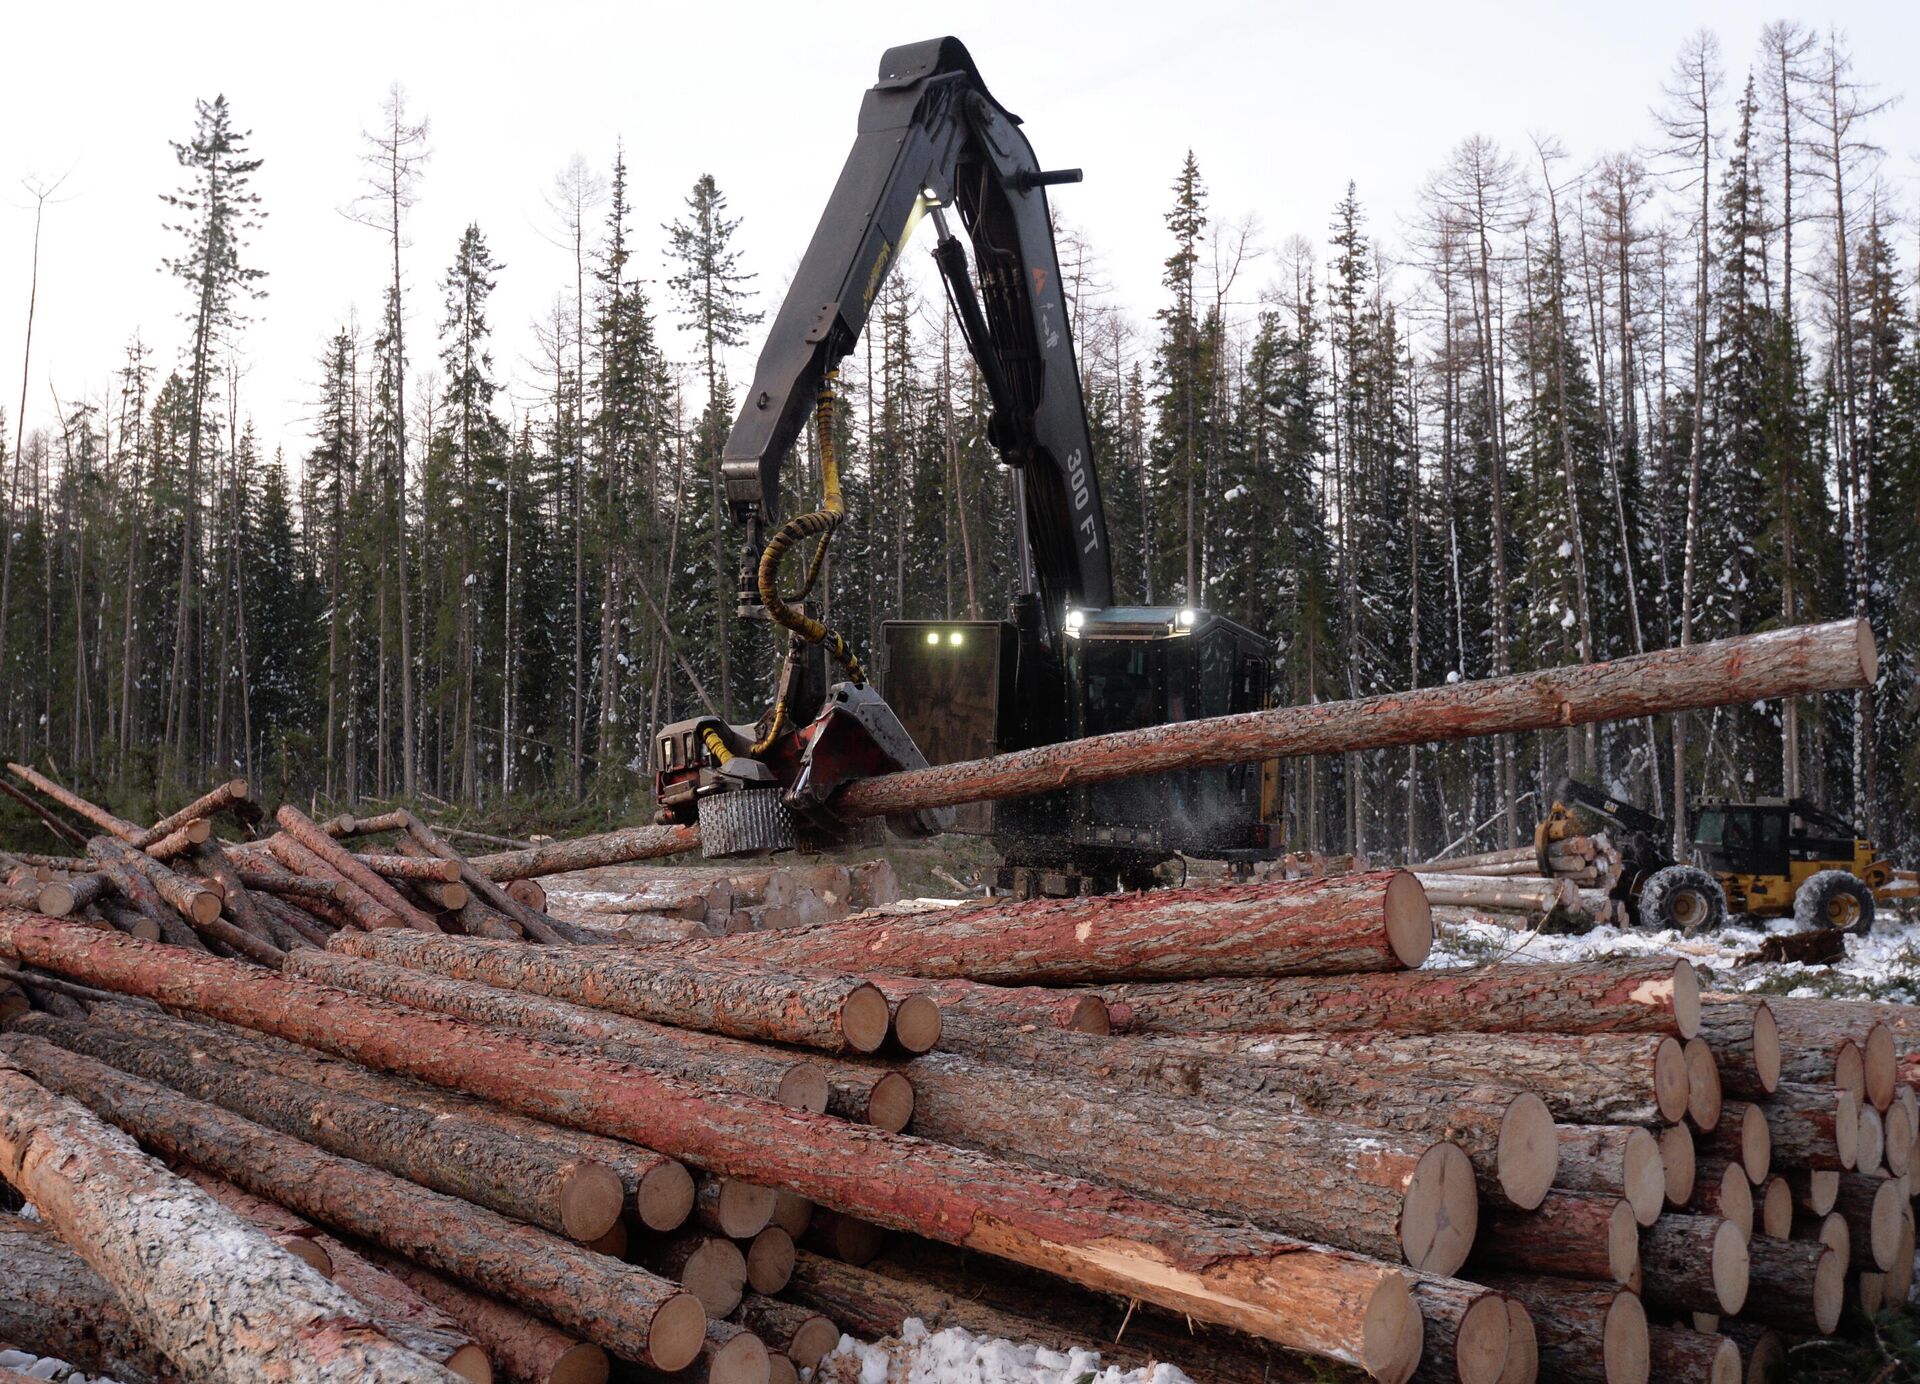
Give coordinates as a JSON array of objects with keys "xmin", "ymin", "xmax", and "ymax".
[{"xmin": 1427, "ymin": 902, "xmax": 1920, "ymax": 1004}]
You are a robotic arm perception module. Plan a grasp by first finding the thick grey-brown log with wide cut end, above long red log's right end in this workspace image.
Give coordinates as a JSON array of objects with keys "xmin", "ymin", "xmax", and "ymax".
[{"xmin": 890, "ymin": 1054, "xmax": 1478, "ymax": 1277}]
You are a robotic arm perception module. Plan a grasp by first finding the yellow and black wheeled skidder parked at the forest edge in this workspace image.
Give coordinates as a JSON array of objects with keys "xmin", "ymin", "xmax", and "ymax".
[{"xmin": 1536, "ymin": 779, "xmax": 1920, "ymax": 935}]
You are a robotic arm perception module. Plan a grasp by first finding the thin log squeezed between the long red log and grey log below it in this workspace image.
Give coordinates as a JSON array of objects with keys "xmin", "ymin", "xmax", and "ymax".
[{"xmin": 90, "ymin": 1004, "xmax": 693, "ymax": 1238}]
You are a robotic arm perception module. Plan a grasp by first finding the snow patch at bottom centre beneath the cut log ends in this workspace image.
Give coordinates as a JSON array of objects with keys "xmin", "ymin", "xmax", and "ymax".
[{"xmin": 808, "ymin": 1317, "xmax": 1194, "ymax": 1384}]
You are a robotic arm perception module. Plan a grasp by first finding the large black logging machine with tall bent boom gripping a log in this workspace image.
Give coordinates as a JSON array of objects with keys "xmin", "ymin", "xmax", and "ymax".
[{"xmin": 655, "ymin": 38, "xmax": 1273, "ymax": 893}]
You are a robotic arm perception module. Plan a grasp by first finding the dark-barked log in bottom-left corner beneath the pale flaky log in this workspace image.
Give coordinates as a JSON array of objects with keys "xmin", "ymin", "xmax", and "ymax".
[{"xmin": 0, "ymin": 1215, "xmax": 177, "ymax": 1384}]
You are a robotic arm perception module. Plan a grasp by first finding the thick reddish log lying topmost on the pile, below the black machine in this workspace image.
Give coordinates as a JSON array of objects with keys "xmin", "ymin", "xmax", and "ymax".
[{"xmin": 651, "ymin": 871, "xmax": 1432, "ymax": 985}]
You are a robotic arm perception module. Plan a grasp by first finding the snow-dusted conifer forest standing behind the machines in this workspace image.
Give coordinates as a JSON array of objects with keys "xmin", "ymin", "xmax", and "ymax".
[{"xmin": 0, "ymin": 23, "xmax": 1920, "ymax": 860}]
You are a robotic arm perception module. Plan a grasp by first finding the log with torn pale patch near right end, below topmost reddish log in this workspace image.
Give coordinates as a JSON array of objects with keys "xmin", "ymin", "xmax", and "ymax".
[{"xmin": 1100, "ymin": 958, "xmax": 1699, "ymax": 1038}]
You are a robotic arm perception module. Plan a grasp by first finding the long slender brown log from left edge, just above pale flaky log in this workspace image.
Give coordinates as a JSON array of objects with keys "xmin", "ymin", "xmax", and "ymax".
[{"xmin": 0, "ymin": 1035, "xmax": 705, "ymax": 1369}]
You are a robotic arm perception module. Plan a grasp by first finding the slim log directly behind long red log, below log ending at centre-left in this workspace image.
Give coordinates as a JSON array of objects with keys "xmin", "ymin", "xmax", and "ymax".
[{"xmin": 286, "ymin": 952, "xmax": 840, "ymax": 1113}]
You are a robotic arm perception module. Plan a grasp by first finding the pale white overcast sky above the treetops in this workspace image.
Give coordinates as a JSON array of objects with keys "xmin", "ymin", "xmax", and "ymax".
[{"xmin": 0, "ymin": 0, "xmax": 1920, "ymax": 459}]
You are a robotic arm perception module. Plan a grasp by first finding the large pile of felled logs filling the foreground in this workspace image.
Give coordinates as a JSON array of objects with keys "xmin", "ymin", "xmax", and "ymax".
[{"xmin": 0, "ymin": 774, "xmax": 1920, "ymax": 1384}]
